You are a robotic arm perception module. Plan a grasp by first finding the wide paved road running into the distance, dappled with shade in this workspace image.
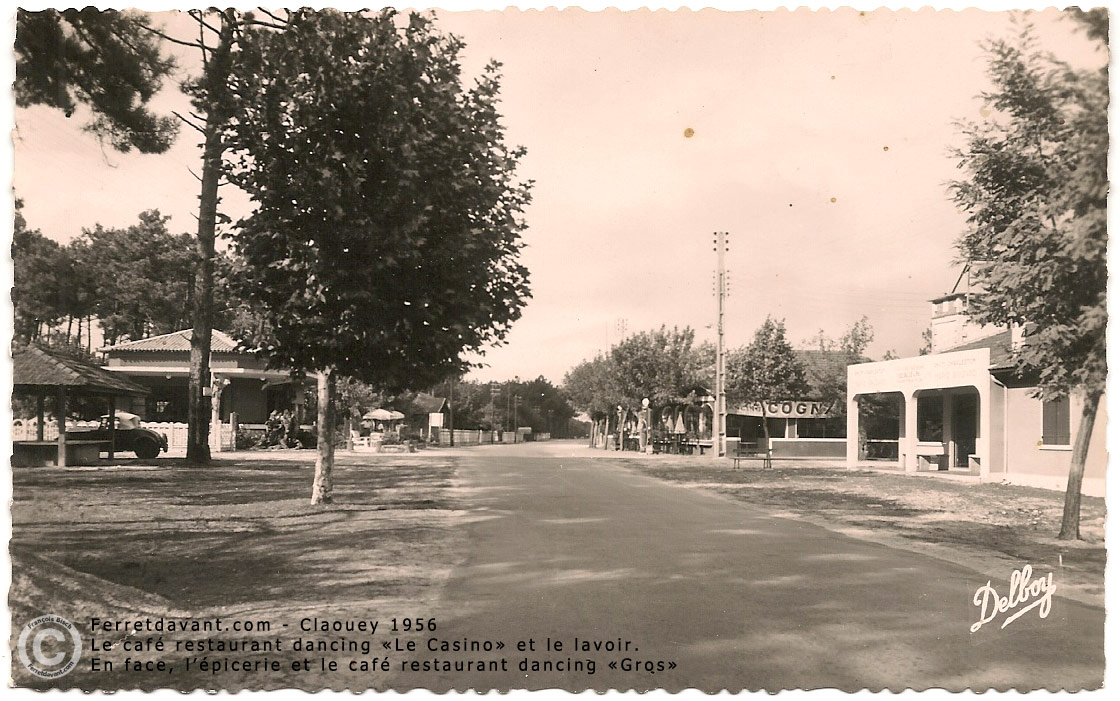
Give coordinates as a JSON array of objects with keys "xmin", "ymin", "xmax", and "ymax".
[{"xmin": 392, "ymin": 445, "xmax": 1104, "ymax": 691}]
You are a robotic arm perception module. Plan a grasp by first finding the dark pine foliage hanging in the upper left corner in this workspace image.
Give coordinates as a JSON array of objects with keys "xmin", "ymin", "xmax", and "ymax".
[{"xmin": 12, "ymin": 7, "xmax": 177, "ymax": 153}]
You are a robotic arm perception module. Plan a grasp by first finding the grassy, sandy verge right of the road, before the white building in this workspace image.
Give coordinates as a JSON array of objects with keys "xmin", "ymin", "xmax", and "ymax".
[{"xmin": 577, "ymin": 451, "xmax": 1107, "ymax": 606}]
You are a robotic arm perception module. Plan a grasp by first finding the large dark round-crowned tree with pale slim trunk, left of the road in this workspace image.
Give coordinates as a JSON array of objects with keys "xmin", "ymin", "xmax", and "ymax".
[{"xmin": 221, "ymin": 10, "xmax": 529, "ymax": 503}]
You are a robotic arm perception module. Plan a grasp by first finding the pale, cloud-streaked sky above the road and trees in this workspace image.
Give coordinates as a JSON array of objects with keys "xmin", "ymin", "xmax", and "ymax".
[{"xmin": 12, "ymin": 4, "xmax": 1107, "ymax": 382}]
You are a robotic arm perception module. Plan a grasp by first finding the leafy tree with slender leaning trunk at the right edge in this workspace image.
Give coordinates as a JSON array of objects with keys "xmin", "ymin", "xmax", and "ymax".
[{"xmin": 951, "ymin": 11, "xmax": 1109, "ymax": 539}]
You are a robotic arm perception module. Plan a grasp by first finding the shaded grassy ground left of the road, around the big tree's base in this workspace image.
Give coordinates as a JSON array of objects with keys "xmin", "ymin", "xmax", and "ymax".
[{"xmin": 9, "ymin": 451, "xmax": 465, "ymax": 690}]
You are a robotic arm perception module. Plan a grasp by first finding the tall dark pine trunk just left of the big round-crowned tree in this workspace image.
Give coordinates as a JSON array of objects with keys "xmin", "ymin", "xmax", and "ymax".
[{"xmin": 187, "ymin": 13, "xmax": 233, "ymax": 465}]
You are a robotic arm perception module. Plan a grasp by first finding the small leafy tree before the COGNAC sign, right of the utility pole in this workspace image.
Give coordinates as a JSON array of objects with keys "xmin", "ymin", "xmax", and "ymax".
[{"xmin": 727, "ymin": 317, "xmax": 809, "ymax": 446}]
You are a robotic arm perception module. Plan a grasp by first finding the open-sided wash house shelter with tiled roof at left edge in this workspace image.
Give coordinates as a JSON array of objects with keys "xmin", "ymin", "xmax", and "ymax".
[{"xmin": 11, "ymin": 346, "xmax": 148, "ymax": 467}]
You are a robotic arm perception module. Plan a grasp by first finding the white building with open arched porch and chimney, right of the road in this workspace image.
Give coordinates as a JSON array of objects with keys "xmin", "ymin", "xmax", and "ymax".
[{"xmin": 847, "ymin": 295, "xmax": 1108, "ymax": 496}]
